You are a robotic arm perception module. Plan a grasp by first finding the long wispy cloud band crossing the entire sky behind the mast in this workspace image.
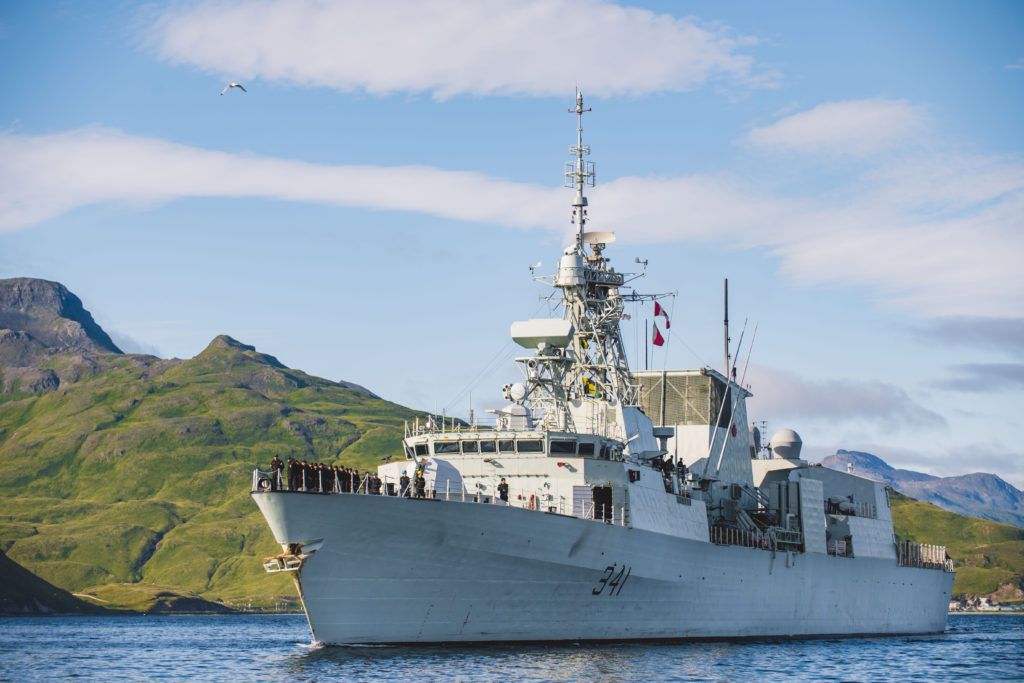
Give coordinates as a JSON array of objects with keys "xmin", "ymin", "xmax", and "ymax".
[{"xmin": 6, "ymin": 128, "xmax": 1024, "ymax": 317}]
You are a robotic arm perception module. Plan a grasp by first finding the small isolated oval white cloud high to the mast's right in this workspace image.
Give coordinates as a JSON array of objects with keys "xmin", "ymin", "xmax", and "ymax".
[{"xmin": 746, "ymin": 99, "xmax": 928, "ymax": 157}]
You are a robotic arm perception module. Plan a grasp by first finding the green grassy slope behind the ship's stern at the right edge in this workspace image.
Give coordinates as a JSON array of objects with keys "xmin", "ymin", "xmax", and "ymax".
[{"xmin": 890, "ymin": 492, "xmax": 1024, "ymax": 601}]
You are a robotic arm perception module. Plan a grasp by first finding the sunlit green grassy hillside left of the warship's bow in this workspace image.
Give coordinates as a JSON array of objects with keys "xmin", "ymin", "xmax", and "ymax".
[{"xmin": 0, "ymin": 337, "xmax": 415, "ymax": 606}]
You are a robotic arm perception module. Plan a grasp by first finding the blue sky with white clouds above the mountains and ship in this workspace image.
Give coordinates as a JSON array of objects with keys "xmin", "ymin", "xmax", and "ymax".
[{"xmin": 0, "ymin": 0, "xmax": 1024, "ymax": 487}]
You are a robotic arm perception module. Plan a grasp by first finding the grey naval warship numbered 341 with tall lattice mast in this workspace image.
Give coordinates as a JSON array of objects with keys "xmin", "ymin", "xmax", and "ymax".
[{"xmin": 252, "ymin": 92, "xmax": 954, "ymax": 644}]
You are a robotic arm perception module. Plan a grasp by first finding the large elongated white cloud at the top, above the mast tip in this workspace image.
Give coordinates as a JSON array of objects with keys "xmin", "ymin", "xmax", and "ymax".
[{"xmin": 142, "ymin": 0, "xmax": 775, "ymax": 98}]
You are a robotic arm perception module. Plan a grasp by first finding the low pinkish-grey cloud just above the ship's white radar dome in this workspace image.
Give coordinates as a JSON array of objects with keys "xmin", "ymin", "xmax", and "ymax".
[{"xmin": 751, "ymin": 367, "xmax": 947, "ymax": 436}]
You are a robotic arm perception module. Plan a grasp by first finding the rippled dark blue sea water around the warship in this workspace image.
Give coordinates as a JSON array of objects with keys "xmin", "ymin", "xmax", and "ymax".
[{"xmin": 0, "ymin": 614, "xmax": 1024, "ymax": 683}]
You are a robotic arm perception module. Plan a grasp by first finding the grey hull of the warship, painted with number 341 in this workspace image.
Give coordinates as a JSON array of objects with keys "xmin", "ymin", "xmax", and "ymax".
[{"xmin": 253, "ymin": 493, "xmax": 953, "ymax": 644}]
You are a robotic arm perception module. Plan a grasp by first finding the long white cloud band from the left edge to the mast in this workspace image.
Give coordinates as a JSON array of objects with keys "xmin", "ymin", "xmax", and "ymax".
[{"xmin": 0, "ymin": 128, "xmax": 564, "ymax": 230}]
